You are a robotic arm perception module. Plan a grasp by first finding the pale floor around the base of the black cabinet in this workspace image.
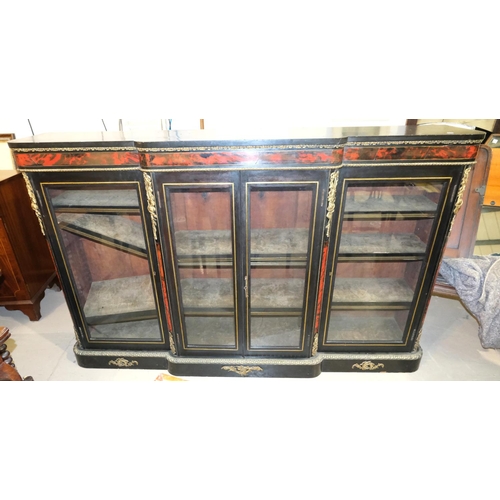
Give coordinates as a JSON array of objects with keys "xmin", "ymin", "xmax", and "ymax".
[{"xmin": 0, "ymin": 290, "xmax": 500, "ymax": 383}]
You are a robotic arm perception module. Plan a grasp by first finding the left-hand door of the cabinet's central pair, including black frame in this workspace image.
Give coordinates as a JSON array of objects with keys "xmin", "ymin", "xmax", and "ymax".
[{"xmin": 155, "ymin": 174, "xmax": 242, "ymax": 355}]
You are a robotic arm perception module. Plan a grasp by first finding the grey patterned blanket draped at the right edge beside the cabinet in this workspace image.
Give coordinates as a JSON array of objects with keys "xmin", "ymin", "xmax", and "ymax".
[{"xmin": 440, "ymin": 255, "xmax": 500, "ymax": 349}]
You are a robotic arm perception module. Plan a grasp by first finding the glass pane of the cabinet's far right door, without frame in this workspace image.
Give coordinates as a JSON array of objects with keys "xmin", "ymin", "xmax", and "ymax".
[{"xmin": 326, "ymin": 179, "xmax": 446, "ymax": 343}]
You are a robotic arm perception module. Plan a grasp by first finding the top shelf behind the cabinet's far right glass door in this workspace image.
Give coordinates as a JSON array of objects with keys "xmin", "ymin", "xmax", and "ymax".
[{"xmin": 344, "ymin": 191, "xmax": 437, "ymax": 217}]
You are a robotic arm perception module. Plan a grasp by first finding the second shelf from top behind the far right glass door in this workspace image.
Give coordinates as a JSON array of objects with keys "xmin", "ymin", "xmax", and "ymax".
[{"xmin": 339, "ymin": 233, "xmax": 426, "ymax": 257}]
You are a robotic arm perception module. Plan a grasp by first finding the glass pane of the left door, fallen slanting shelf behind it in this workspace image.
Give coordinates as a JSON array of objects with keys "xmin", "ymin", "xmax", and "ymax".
[{"xmin": 42, "ymin": 186, "xmax": 163, "ymax": 343}]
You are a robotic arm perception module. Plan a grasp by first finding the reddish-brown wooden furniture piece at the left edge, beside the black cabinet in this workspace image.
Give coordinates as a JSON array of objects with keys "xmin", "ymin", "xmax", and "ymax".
[{"xmin": 0, "ymin": 170, "xmax": 59, "ymax": 321}]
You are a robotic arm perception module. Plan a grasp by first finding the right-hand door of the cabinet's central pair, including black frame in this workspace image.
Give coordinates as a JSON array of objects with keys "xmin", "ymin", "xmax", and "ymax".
[{"xmin": 243, "ymin": 172, "xmax": 326, "ymax": 356}]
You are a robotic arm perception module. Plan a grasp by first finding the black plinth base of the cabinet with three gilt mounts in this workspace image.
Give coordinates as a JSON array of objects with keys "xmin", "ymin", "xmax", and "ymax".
[{"xmin": 74, "ymin": 344, "xmax": 422, "ymax": 378}]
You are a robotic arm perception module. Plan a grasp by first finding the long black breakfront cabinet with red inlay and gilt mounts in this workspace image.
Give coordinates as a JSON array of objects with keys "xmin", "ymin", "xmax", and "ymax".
[{"xmin": 9, "ymin": 126, "xmax": 484, "ymax": 377}]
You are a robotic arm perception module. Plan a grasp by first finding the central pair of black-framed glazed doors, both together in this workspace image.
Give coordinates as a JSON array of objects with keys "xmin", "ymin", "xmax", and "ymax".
[{"xmin": 155, "ymin": 172, "xmax": 324, "ymax": 356}]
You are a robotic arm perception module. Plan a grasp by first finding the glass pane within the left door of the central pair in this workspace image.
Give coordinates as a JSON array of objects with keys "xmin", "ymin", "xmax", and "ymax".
[{"xmin": 163, "ymin": 183, "xmax": 238, "ymax": 349}]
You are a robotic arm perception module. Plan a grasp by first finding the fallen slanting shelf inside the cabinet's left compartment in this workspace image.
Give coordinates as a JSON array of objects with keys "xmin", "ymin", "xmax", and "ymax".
[{"xmin": 57, "ymin": 212, "xmax": 147, "ymax": 257}]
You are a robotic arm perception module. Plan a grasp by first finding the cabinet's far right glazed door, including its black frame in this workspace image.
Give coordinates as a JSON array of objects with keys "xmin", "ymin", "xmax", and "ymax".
[{"xmin": 320, "ymin": 169, "xmax": 458, "ymax": 350}]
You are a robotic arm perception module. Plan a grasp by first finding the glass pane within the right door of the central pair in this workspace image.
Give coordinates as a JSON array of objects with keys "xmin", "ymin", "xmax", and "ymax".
[{"xmin": 246, "ymin": 182, "xmax": 317, "ymax": 350}]
